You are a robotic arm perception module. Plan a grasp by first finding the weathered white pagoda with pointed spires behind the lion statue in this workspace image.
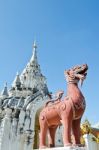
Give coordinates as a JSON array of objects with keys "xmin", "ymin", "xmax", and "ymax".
[{"xmin": 0, "ymin": 42, "xmax": 48, "ymax": 150}]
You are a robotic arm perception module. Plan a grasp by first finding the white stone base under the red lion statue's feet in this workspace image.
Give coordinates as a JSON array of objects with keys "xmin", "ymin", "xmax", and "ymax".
[{"xmin": 36, "ymin": 146, "xmax": 87, "ymax": 150}]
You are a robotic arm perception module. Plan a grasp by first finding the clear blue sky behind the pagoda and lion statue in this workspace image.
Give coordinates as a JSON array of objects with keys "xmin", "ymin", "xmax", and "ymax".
[{"xmin": 0, "ymin": 0, "xmax": 99, "ymax": 124}]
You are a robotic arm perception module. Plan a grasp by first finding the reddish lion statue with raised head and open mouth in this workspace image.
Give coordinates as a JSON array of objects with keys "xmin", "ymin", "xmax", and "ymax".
[{"xmin": 39, "ymin": 64, "xmax": 88, "ymax": 149}]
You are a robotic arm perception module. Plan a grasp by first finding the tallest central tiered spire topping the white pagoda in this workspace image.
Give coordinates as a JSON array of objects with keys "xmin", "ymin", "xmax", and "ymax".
[{"xmin": 20, "ymin": 41, "xmax": 46, "ymax": 90}]
